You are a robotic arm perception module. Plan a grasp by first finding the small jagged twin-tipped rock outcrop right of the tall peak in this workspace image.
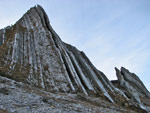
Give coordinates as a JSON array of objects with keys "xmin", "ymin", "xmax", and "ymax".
[{"xmin": 114, "ymin": 67, "xmax": 150, "ymax": 110}]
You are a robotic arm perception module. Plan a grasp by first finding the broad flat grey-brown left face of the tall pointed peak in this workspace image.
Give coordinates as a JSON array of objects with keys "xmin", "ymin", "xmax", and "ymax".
[{"xmin": 0, "ymin": 6, "xmax": 69, "ymax": 92}]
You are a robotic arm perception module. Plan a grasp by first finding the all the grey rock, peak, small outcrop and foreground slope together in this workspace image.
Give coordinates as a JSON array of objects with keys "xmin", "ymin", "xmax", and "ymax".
[{"xmin": 0, "ymin": 5, "xmax": 150, "ymax": 113}]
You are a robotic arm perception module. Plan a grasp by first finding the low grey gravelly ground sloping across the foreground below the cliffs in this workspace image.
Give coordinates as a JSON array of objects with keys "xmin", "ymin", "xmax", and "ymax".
[{"xmin": 0, "ymin": 76, "xmax": 141, "ymax": 113}]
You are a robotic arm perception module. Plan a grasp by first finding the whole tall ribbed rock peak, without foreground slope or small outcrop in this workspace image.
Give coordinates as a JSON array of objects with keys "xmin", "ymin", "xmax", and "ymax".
[{"xmin": 0, "ymin": 6, "xmax": 117, "ymax": 102}]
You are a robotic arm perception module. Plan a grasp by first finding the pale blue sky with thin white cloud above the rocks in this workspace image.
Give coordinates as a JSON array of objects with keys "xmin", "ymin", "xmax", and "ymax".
[{"xmin": 0, "ymin": 0, "xmax": 150, "ymax": 91}]
